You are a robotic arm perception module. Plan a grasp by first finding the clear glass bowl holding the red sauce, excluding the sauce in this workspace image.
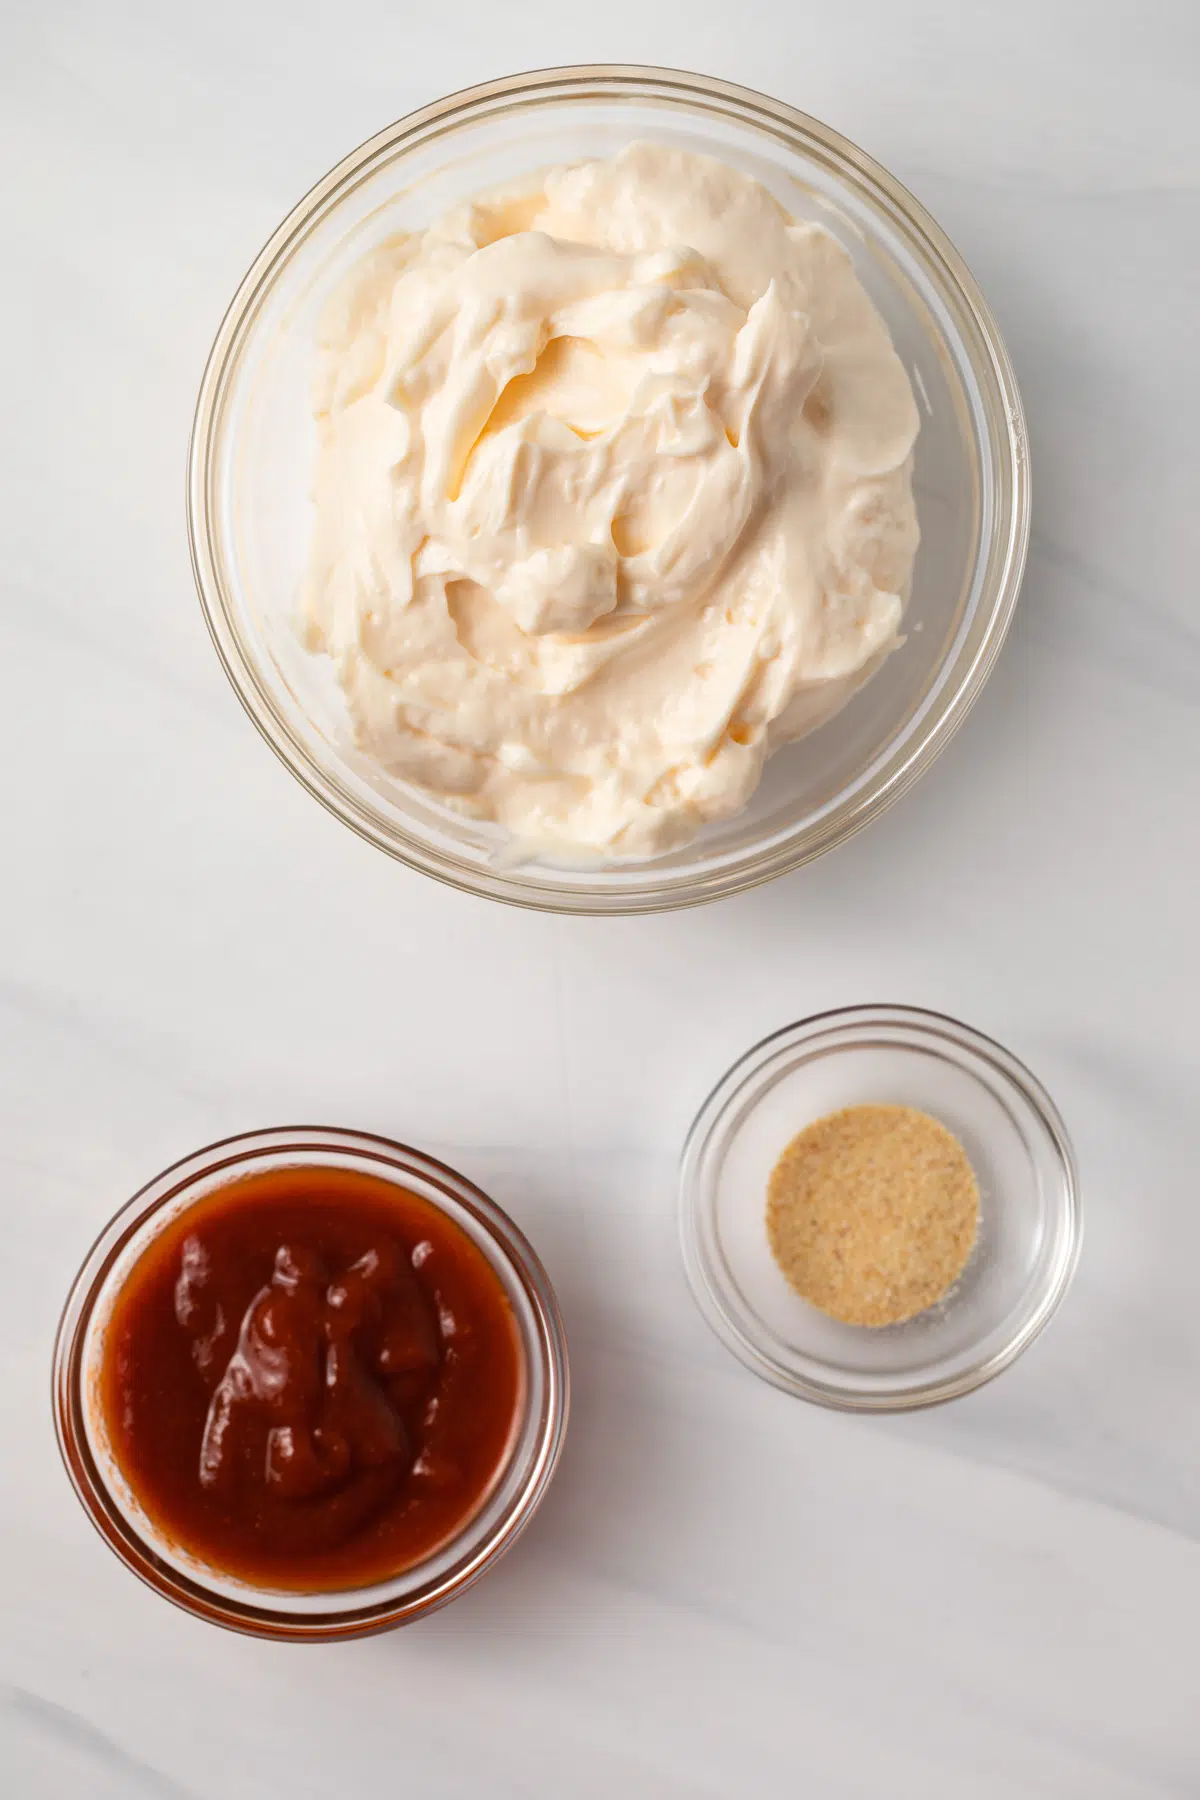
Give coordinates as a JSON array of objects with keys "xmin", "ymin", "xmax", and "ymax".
[{"xmin": 54, "ymin": 1127, "xmax": 569, "ymax": 1642}]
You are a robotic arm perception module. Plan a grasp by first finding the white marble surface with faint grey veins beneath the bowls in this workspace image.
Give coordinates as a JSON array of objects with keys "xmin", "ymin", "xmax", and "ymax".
[{"xmin": 0, "ymin": 0, "xmax": 1200, "ymax": 1800}]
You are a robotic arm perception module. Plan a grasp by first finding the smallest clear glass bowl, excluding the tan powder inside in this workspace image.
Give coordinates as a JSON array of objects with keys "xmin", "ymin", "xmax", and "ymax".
[{"xmin": 680, "ymin": 1006, "xmax": 1081, "ymax": 1413}]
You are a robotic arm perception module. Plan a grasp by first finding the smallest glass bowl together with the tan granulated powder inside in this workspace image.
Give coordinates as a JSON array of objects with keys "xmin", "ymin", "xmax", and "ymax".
[{"xmin": 680, "ymin": 1006, "xmax": 1081, "ymax": 1411}]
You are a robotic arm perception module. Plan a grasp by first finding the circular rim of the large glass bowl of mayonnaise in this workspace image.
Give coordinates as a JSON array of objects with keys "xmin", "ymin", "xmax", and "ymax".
[{"xmin": 187, "ymin": 63, "xmax": 1031, "ymax": 914}]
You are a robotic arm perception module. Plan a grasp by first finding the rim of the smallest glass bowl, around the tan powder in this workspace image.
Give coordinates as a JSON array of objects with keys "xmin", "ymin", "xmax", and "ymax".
[{"xmin": 678, "ymin": 1003, "xmax": 1083, "ymax": 1413}]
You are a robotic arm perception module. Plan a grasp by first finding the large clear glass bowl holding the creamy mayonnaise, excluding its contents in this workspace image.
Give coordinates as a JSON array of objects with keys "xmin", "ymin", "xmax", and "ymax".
[{"xmin": 187, "ymin": 67, "xmax": 1029, "ymax": 913}]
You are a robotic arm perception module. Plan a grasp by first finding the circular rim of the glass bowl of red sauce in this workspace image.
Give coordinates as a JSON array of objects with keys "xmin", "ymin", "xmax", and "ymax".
[{"xmin": 52, "ymin": 1125, "xmax": 570, "ymax": 1643}]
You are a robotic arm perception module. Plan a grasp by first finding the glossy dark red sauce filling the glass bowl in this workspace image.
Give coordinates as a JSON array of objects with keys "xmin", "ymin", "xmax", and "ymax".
[{"xmin": 99, "ymin": 1166, "xmax": 522, "ymax": 1591}]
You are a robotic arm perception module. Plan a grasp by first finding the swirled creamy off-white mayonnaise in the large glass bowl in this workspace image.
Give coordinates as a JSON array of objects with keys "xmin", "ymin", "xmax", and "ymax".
[{"xmin": 308, "ymin": 142, "xmax": 918, "ymax": 859}]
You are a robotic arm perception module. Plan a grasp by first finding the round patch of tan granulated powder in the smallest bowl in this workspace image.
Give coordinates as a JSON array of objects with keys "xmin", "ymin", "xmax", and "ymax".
[{"xmin": 766, "ymin": 1105, "xmax": 979, "ymax": 1325}]
